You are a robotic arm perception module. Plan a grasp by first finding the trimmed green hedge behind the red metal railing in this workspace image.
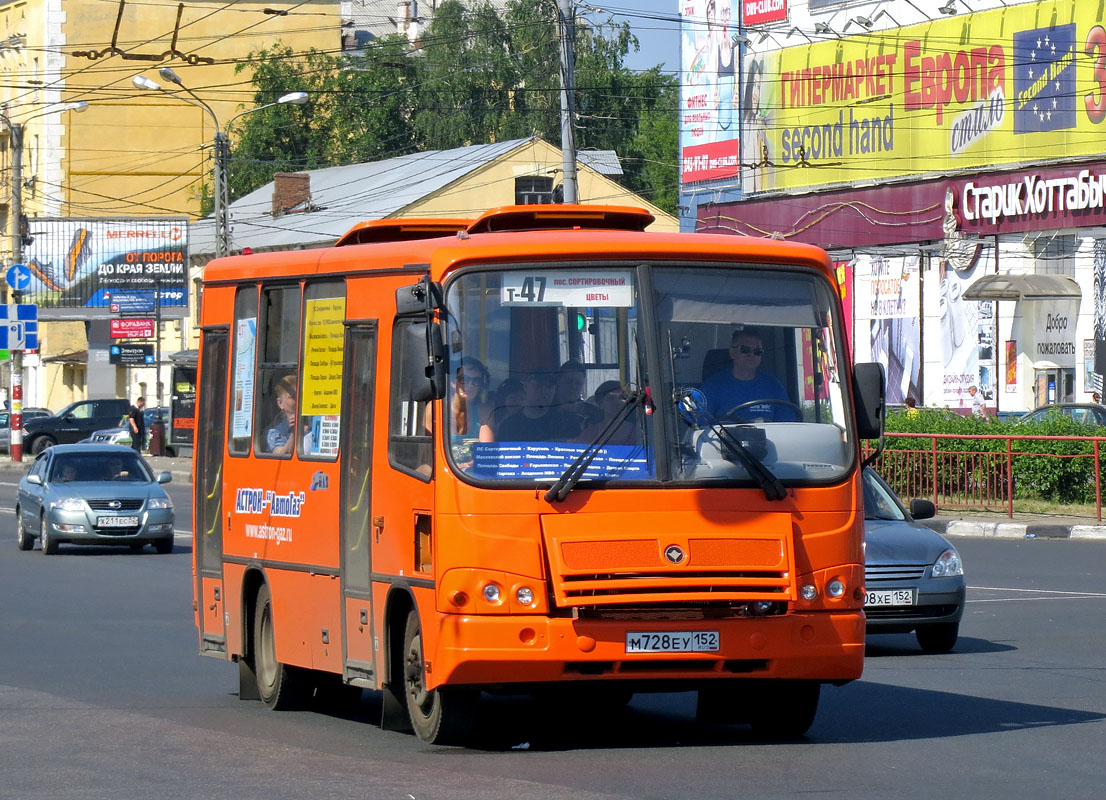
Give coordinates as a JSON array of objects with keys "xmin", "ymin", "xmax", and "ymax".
[{"xmin": 880, "ymin": 408, "xmax": 1106, "ymax": 503}]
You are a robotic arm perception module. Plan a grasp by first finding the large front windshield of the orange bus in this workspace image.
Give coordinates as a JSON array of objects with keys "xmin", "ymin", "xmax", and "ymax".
[{"xmin": 444, "ymin": 262, "xmax": 855, "ymax": 486}]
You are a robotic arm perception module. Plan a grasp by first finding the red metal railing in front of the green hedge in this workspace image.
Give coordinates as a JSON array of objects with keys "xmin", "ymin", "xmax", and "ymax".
[{"xmin": 865, "ymin": 433, "xmax": 1106, "ymax": 522}]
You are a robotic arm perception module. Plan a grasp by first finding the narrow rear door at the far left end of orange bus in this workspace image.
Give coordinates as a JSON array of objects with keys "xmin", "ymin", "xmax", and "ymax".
[{"xmin": 192, "ymin": 330, "xmax": 229, "ymax": 656}]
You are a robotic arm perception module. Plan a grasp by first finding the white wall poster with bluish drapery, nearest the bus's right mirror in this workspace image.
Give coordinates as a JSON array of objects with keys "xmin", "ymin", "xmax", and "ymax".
[{"xmin": 870, "ymin": 256, "xmax": 921, "ymax": 403}]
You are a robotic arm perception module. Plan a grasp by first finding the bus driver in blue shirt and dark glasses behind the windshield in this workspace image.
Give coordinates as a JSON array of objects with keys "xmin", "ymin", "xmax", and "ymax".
[{"xmin": 702, "ymin": 328, "xmax": 799, "ymax": 423}]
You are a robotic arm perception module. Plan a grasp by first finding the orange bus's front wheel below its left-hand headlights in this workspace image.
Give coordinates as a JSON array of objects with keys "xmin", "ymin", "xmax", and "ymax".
[{"xmin": 403, "ymin": 609, "xmax": 478, "ymax": 745}]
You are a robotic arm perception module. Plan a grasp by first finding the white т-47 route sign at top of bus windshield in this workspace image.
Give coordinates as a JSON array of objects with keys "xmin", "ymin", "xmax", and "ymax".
[{"xmin": 499, "ymin": 269, "xmax": 634, "ymax": 309}]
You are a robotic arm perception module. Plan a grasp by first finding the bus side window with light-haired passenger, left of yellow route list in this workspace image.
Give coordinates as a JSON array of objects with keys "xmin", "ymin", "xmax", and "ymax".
[{"xmin": 253, "ymin": 285, "xmax": 300, "ymax": 457}]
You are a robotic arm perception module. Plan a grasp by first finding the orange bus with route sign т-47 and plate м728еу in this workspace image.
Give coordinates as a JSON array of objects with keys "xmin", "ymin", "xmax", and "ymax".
[{"xmin": 194, "ymin": 206, "xmax": 884, "ymax": 742}]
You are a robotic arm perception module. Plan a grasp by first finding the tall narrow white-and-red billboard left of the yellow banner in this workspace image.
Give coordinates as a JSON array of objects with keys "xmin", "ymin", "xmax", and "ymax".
[{"xmin": 680, "ymin": 0, "xmax": 741, "ymax": 184}]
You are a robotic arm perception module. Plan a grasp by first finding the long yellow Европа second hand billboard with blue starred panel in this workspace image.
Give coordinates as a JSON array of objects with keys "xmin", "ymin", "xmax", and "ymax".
[{"xmin": 742, "ymin": 0, "xmax": 1106, "ymax": 193}]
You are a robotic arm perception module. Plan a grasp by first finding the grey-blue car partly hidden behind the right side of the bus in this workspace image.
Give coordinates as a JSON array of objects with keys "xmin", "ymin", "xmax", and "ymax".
[{"xmin": 864, "ymin": 468, "xmax": 964, "ymax": 653}]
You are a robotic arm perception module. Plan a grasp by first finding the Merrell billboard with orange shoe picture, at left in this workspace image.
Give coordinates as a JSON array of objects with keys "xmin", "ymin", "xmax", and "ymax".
[{"xmin": 16, "ymin": 218, "xmax": 188, "ymax": 320}]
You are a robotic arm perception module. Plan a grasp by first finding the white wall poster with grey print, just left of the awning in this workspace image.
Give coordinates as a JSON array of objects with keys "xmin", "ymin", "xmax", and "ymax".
[{"xmin": 938, "ymin": 250, "xmax": 995, "ymax": 408}]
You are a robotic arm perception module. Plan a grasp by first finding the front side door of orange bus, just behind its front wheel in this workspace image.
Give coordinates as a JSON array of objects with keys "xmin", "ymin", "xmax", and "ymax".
[{"xmin": 338, "ymin": 323, "xmax": 377, "ymax": 688}]
